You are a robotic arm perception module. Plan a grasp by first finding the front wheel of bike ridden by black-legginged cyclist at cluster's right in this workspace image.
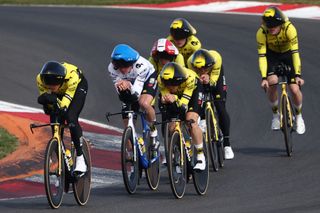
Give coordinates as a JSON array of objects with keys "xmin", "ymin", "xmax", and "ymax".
[{"xmin": 205, "ymin": 106, "xmax": 219, "ymax": 172}]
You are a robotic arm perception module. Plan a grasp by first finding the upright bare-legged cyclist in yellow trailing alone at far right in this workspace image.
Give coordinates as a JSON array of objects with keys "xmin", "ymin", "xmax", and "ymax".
[{"xmin": 256, "ymin": 7, "xmax": 305, "ymax": 134}]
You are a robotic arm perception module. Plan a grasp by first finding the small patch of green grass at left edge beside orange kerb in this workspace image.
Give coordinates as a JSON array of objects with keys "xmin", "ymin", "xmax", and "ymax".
[{"xmin": 0, "ymin": 128, "xmax": 18, "ymax": 159}]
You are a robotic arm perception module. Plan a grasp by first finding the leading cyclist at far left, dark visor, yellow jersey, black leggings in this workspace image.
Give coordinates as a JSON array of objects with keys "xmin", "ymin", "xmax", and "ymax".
[{"xmin": 37, "ymin": 61, "xmax": 88, "ymax": 173}]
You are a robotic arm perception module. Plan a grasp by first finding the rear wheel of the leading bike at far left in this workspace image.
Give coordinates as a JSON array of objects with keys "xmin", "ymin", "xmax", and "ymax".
[{"xmin": 72, "ymin": 139, "xmax": 91, "ymax": 206}]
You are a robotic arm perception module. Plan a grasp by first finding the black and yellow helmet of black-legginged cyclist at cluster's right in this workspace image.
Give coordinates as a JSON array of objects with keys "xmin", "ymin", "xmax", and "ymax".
[{"xmin": 191, "ymin": 49, "xmax": 215, "ymax": 69}]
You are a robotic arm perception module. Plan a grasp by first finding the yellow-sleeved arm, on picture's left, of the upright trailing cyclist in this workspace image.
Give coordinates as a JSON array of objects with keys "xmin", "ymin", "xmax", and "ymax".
[{"xmin": 256, "ymin": 27, "xmax": 267, "ymax": 79}]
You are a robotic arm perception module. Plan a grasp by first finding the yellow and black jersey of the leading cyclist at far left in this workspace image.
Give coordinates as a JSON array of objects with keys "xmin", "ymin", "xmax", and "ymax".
[{"xmin": 37, "ymin": 62, "xmax": 82, "ymax": 108}]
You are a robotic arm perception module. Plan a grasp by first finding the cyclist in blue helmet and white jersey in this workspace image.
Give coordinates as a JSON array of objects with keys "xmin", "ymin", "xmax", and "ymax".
[{"xmin": 108, "ymin": 44, "xmax": 159, "ymax": 149}]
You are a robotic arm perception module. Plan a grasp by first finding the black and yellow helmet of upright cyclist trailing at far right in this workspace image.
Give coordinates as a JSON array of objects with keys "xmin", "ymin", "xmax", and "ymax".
[{"xmin": 262, "ymin": 7, "xmax": 287, "ymax": 28}]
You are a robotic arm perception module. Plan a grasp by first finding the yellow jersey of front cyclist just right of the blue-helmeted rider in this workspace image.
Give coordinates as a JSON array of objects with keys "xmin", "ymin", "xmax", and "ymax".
[{"xmin": 158, "ymin": 67, "xmax": 198, "ymax": 107}]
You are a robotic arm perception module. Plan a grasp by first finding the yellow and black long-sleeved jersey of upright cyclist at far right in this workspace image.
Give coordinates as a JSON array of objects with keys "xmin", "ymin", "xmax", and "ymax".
[{"xmin": 256, "ymin": 20, "xmax": 301, "ymax": 78}]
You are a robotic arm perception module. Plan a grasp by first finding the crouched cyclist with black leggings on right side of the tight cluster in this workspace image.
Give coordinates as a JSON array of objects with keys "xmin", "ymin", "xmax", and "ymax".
[{"xmin": 188, "ymin": 49, "xmax": 234, "ymax": 159}]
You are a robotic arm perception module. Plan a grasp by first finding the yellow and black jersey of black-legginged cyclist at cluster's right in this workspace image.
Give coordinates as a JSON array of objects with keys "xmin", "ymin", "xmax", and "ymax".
[{"xmin": 187, "ymin": 50, "xmax": 222, "ymax": 86}]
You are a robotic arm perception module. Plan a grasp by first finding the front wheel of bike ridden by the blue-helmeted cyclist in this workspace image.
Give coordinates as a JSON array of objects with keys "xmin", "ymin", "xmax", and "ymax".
[{"xmin": 121, "ymin": 127, "xmax": 139, "ymax": 194}]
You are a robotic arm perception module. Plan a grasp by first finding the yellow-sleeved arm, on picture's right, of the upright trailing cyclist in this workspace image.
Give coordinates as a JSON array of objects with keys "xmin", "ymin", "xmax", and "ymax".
[{"xmin": 286, "ymin": 24, "xmax": 301, "ymax": 76}]
